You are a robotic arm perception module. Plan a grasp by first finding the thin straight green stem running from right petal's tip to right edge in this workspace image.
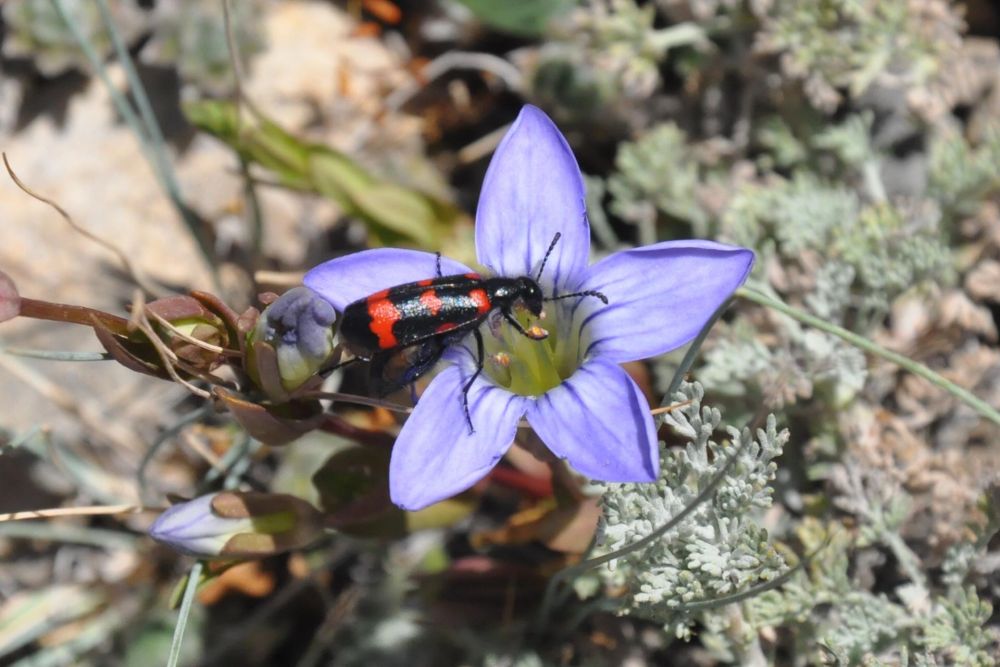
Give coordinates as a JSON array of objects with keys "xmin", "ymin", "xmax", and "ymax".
[{"xmin": 736, "ymin": 287, "xmax": 1000, "ymax": 424}]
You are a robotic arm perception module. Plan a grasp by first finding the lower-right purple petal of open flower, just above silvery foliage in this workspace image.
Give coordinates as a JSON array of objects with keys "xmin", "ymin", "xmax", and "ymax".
[{"xmin": 528, "ymin": 360, "xmax": 660, "ymax": 482}]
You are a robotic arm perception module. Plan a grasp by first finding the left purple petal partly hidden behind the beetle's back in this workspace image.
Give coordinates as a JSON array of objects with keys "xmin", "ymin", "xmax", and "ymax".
[{"xmin": 302, "ymin": 248, "xmax": 472, "ymax": 311}]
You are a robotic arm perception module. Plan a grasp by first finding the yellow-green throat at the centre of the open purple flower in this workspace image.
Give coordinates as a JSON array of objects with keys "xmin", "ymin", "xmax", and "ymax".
[{"xmin": 482, "ymin": 303, "xmax": 581, "ymax": 396}]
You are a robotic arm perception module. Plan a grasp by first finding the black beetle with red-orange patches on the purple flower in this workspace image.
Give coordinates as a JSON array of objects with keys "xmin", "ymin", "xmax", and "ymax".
[{"xmin": 340, "ymin": 233, "xmax": 608, "ymax": 433}]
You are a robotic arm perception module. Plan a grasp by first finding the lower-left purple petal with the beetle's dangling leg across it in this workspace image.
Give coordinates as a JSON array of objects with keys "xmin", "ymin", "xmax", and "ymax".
[{"xmin": 389, "ymin": 366, "xmax": 526, "ymax": 511}]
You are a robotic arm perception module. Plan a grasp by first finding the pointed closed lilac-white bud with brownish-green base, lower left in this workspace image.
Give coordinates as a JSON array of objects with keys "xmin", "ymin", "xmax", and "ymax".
[{"xmin": 149, "ymin": 491, "xmax": 323, "ymax": 559}]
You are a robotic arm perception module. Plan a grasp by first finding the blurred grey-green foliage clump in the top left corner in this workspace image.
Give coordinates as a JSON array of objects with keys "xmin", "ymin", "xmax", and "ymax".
[{"xmin": 2, "ymin": 0, "xmax": 145, "ymax": 76}]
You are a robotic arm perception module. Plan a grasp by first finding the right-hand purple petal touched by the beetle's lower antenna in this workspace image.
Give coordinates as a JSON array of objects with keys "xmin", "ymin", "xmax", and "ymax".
[{"xmin": 575, "ymin": 241, "xmax": 754, "ymax": 363}]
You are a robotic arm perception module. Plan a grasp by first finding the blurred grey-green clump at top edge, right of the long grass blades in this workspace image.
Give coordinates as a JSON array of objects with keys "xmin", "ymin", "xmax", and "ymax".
[{"xmin": 142, "ymin": 0, "xmax": 265, "ymax": 92}]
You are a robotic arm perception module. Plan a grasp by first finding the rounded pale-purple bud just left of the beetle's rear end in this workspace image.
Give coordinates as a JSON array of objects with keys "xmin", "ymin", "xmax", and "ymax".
[{"xmin": 249, "ymin": 287, "xmax": 337, "ymax": 391}]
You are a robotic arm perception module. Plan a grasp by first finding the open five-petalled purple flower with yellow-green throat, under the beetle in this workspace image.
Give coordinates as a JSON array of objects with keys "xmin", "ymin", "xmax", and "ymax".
[{"xmin": 304, "ymin": 106, "xmax": 753, "ymax": 510}]
